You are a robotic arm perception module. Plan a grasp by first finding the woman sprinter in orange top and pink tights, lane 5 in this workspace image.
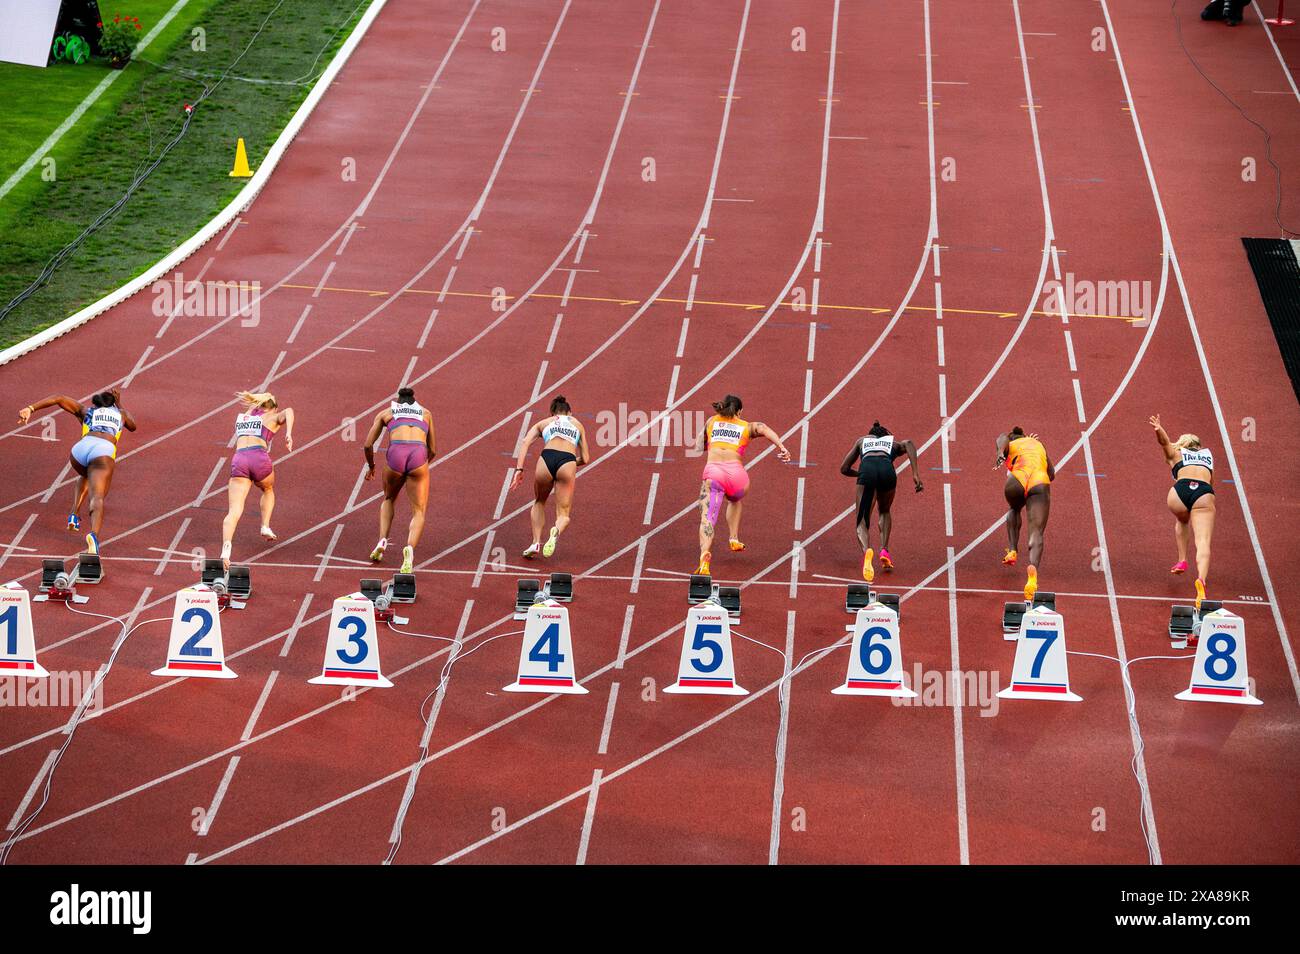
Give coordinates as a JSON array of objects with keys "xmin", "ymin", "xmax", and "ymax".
[{"xmin": 696, "ymin": 394, "xmax": 790, "ymax": 573}]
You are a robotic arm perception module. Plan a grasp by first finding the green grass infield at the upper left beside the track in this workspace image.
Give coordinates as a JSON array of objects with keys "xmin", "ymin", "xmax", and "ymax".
[{"xmin": 0, "ymin": 0, "xmax": 367, "ymax": 347}]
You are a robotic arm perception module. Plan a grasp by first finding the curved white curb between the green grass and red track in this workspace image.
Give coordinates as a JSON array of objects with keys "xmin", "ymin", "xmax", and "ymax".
[{"xmin": 0, "ymin": 0, "xmax": 387, "ymax": 365}]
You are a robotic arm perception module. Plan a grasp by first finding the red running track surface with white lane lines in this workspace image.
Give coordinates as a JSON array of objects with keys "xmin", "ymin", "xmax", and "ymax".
[{"xmin": 0, "ymin": 0, "xmax": 1300, "ymax": 863}]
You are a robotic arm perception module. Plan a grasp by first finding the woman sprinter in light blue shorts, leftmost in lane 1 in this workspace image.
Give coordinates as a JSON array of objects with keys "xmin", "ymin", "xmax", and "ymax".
[{"xmin": 18, "ymin": 387, "xmax": 135, "ymax": 554}]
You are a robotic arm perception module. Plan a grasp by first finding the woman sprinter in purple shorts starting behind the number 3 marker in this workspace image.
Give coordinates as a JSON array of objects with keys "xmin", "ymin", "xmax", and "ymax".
[{"xmin": 361, "ymin": 387, "xmax": 434, "ymax": 573}]
